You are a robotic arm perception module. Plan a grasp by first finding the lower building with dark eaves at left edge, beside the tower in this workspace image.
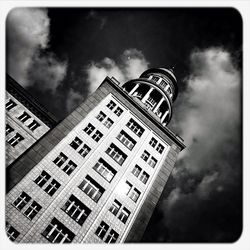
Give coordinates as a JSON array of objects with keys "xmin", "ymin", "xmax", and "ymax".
[{"xmin": 6, "ymin": 75, "xmax": 56, "ymax": 167}]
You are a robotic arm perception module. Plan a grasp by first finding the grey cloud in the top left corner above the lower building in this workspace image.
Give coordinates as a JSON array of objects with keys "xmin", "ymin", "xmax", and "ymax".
[{"xmin": 6, "ymin": 8, "xmax": 67, "ymax": 90}]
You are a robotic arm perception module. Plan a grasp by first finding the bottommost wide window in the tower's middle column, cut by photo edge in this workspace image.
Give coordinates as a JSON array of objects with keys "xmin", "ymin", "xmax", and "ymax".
[{"xmin": 42, "ymin": 218, "xmax": 75, "ymax": 243}]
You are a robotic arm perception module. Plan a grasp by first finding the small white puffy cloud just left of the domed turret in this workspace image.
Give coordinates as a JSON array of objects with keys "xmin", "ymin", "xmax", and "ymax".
[{"xmin": 86, "ymin": 49, "xmax": 149, "ymax": 93}]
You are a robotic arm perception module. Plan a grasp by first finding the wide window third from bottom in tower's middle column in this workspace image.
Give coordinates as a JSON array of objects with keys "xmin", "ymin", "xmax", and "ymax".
[{"xmin": 79, "ymin": 175, "xmax": 105, "ymax": 202}]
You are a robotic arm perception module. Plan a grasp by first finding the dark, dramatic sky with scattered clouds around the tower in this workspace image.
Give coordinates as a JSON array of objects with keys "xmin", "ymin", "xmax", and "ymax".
[{"xmin": 6, "ymin": 8, "xmax": 242, "ymax": 242}]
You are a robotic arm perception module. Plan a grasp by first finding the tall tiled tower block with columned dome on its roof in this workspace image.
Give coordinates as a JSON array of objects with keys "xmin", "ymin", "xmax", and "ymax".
[{"xmin": 6, "ymin": 68, "xmax": 185, "ymax": 243}]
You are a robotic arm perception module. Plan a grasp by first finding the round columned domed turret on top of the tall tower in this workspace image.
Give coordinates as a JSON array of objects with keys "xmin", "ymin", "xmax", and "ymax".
[{"xmin": 123, "ymin": 68, "xmax": 178, "ymax": 126}]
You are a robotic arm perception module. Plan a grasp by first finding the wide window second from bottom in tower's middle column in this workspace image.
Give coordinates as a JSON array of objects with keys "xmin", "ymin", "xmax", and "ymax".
[{"xmin": 62, "ymin": 195, "xmax": 91, "ymax": 226}]
